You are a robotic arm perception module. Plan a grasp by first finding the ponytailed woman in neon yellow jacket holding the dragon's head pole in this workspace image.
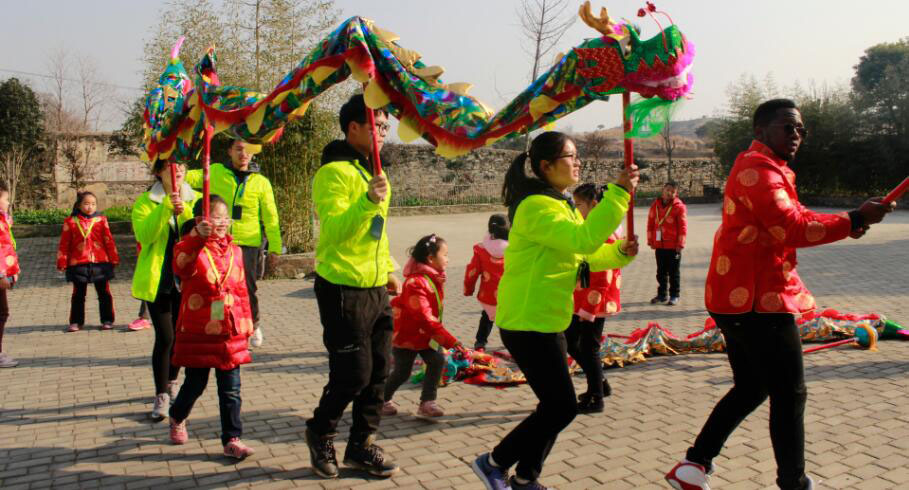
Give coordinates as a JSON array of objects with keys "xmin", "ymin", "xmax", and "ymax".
[{"xmin": 472, "ymin": 131, "xmax": 638, "ymax": 490}]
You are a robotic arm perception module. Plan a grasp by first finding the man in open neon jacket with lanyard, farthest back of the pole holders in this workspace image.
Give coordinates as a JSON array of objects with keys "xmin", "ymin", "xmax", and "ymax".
[{"xmin": 186, "ymin": 140, "xmax": 282, "ymax": 347}]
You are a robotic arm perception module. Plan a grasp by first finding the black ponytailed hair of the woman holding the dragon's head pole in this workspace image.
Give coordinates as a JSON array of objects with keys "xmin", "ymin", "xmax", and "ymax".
[{"xmin": 502, "ymin": 131, "xmax": 571, "ymax": 208}]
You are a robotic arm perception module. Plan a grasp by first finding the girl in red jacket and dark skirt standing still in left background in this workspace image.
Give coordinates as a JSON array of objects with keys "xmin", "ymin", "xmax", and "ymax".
[{"xmin": 57, "ymin": 191, "xmax": 120, "ymax": 332}]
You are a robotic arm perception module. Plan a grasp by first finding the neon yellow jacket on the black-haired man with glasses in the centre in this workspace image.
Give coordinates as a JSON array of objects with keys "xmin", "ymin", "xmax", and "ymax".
[{"xmin": 312, "ymin": 155, "xmax": 395, "ymax": 288}]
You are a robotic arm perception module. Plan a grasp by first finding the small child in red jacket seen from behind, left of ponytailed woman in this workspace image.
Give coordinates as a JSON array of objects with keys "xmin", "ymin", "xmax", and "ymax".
[{"xmin": 464, "ymin": 214, "xmax": 508, "ymax": 352}]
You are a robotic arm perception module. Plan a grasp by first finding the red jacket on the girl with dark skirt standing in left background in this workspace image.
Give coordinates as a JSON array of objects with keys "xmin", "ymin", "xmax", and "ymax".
[{"xmin": 57, "ymin": 214, "xmax": 120, "ymax": 270}]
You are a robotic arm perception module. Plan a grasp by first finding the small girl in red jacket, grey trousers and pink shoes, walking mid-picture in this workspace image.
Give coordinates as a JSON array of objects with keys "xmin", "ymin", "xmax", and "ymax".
[{"xmin": 382, "ymin": 234, "xmax": 464, "ymax": 417}]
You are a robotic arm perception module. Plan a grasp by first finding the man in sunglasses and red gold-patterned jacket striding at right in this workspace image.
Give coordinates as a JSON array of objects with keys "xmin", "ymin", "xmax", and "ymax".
[{"xmin": 666, "ymin": 99, "xmax": 893, "ymax": 489}]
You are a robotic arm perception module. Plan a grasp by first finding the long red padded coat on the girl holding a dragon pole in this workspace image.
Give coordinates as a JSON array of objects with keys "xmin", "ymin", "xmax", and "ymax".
[{"xmin": 173, "ymin": 231, "xmax": 253, "ymax": 370}]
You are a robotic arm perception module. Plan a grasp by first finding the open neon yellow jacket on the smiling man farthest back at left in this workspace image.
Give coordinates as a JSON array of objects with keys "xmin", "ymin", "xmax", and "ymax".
[{"xmin": 186, "ymin": 163, "xmax": 282, "ymax": 254}]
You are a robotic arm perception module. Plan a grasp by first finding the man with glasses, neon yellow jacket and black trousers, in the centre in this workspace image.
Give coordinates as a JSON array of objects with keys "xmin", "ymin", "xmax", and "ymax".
[{"xmin": 306, "ymin": 94, "xmax": 401, "ymax": 478}]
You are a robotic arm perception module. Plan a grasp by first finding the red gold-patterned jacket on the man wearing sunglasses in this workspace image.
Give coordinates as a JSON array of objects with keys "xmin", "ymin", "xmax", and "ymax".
[{"xmin": 704, "ymin": 141, "xmax": 852, "ymax": 314}]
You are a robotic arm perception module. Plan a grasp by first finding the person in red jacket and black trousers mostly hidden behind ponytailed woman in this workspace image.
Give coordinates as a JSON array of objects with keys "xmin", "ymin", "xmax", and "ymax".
[{"xmin": 565, "ymin": 183, "xmax": 622, "ymax": 413}]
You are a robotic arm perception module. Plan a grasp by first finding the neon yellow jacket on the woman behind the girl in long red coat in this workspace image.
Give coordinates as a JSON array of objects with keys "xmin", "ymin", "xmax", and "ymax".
[{"xmin": 132, "ymin": 182, "xmax": 201, "ymax": 301}]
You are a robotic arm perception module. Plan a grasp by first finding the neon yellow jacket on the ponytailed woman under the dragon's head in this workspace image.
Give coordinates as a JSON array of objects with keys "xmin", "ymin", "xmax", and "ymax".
[{"xmin": 496, "ymin": 185, "xmax": 634, "ymax": 333}]
